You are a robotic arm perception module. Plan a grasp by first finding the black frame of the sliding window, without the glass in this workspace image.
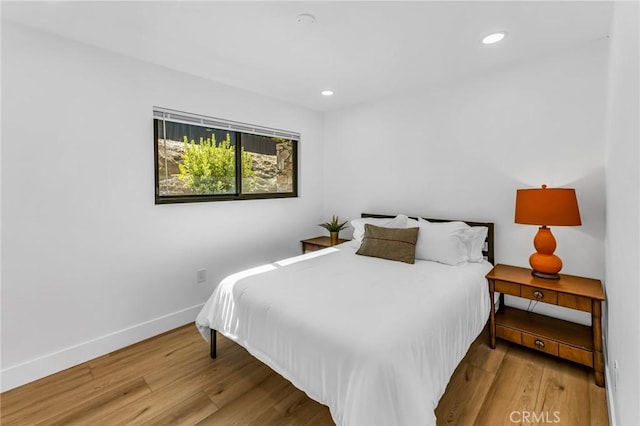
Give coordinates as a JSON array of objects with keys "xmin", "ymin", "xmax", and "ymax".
[{"xmin": 153, "ymin": 109, "xmax": 300, "ymax": 204}]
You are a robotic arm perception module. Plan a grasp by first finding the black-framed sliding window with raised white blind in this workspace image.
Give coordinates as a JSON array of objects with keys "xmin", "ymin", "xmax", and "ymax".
[{"xmin": 153, "ymin": 107, "xmax": 300, "ymax": 204}]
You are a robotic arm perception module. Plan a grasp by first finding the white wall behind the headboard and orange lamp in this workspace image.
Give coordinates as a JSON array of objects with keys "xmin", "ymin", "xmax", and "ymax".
[{"xmin": 324, "ymin": 40, "xmax": 608, "ymax": 322}]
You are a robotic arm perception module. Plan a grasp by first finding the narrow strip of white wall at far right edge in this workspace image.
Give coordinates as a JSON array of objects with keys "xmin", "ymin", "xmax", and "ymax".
[{"xmin": 606, "ymin": 2, "xmax": 640, "ymax": 425}]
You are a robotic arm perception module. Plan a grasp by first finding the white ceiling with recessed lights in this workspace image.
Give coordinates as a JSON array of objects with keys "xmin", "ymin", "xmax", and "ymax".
[{"xmin": 2, "ymin": 1, "xmax": 612, "ymax": 111}]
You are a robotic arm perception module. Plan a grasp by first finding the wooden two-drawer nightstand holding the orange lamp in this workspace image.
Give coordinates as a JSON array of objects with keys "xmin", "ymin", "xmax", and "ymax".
[{"xmin": 487, "ymin": 265, "xmax": 604, "ymax": 386}]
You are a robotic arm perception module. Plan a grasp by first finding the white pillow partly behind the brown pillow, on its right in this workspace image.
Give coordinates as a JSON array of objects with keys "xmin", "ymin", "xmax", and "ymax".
[{"xmin": 416, "ymin": 218, "xmax": 470, "ymax": 265}]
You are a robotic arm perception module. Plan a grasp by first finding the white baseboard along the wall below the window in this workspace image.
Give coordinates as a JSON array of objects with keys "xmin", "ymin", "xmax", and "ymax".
[{"xmin": 0, "ymin": 304, "xmax": 204, "ymax": 392}]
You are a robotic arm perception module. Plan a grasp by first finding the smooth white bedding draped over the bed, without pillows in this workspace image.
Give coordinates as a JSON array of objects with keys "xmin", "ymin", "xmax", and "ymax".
[{"xmin": 196, "ymin": 241, "xmax": 491, "ymax": 425}]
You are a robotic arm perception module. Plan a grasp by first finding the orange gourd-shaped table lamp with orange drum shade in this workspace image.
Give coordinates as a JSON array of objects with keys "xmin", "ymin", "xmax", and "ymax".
[{"xmin": 515, "ymin": 185, "xmax": 582, "ymax": 280}]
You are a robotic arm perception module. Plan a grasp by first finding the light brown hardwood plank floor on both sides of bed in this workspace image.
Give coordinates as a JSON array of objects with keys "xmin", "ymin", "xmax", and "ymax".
[{"xmin": 0, "ymin": 324, "xmax": 608, "ymax": 426}]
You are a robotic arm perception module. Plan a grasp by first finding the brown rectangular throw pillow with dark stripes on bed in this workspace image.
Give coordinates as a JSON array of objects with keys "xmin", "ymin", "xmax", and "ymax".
[{"xmin": 356, "ymin": 223, "xmax": 420, "ymax": 263}]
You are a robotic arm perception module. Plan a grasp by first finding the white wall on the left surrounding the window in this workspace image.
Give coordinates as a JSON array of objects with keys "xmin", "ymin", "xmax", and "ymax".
[{"xmin": 2, "ymin": 22, "xmax": 323, "ymax": 390}]
